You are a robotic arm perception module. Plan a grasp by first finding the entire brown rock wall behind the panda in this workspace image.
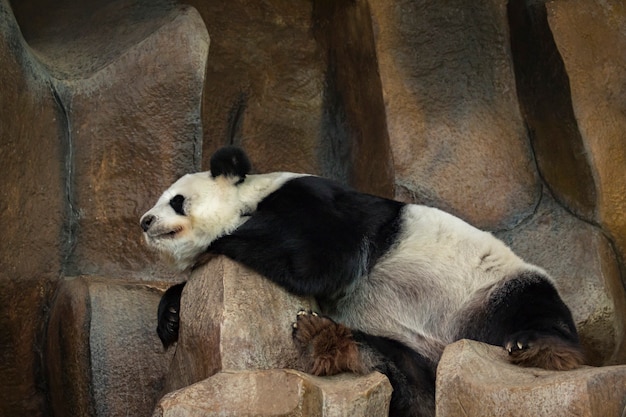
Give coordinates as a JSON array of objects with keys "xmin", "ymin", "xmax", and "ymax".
[{"xmin": 0, "ymin": 0, "xmax": 626, "ymax": 416}]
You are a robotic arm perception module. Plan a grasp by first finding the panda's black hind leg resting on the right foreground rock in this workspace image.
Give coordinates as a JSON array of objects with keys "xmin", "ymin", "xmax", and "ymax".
[{"xmin": 478, "ymin": 272, "xmax": 584, "ymax": 370}]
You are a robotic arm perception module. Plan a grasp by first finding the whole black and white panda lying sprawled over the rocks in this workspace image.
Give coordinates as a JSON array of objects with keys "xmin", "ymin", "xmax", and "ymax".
[{"xmin": 141, "ymin": 147, "xmax": 583, "ymax": 416}]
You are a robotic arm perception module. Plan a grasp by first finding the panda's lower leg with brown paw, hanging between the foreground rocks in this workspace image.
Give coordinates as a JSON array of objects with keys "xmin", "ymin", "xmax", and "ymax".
[{"xmin": 293, "ymin": 311, "xmax": 437, "ymax": 417}]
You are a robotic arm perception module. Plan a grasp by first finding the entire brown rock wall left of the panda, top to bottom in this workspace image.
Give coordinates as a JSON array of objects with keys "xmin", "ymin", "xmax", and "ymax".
[{"xmin": 0, "ymin": 0, "xmax": 209, "ymax": 416}]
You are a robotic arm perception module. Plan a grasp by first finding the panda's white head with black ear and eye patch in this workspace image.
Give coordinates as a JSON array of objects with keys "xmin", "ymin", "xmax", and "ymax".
[{"xmin": 140, "ymin": 147, "xmax": 251, "ymax": 269}]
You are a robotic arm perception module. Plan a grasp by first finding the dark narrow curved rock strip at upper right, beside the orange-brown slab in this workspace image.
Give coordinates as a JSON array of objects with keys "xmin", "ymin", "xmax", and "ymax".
[{"xmin": 508, "ymin": 0, "xmax": 597, "ymax": 221}]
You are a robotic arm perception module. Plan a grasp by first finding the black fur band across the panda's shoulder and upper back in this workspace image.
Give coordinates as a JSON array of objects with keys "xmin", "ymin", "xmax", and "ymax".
[{"xmin": 208, "ymin": 176, "xmax": 404, "ymax": 297}]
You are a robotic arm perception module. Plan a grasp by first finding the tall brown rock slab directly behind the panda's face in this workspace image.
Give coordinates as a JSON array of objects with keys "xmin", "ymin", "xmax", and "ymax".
[{"xmin": 35, "ymin": 4, "xmax": 209, "ymax": 279}]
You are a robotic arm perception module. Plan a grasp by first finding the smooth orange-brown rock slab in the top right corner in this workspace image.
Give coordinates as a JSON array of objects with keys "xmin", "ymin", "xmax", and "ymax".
[{"xmin": 546, "ymin": 0, "xmax": 626, "ymax": 298}]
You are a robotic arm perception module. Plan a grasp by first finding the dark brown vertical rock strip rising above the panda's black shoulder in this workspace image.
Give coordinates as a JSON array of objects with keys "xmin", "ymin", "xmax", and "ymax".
[{"xmin": 313, "ymin": 0, "xmax": 394, "ymax": 198}]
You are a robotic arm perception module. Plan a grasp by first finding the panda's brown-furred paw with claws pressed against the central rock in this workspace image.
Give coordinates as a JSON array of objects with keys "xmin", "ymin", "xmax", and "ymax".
[{"xmin": 292, "ymin": 310, "xmax": 364, "ymax": 376}]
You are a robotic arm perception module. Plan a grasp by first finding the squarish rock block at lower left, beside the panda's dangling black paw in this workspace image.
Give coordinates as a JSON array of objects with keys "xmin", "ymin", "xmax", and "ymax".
[{"xmin": 45, "ymin": 277, "xmax": 172, "ymax": 417}]
